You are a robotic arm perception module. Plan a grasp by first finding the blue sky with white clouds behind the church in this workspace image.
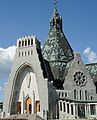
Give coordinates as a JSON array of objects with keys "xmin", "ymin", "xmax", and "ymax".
[{"xmin": 0, "ymin": 0, "xmax": 97, "ymax": 101}]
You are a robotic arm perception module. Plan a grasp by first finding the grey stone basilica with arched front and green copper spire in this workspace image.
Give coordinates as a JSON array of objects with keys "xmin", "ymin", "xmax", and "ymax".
[{"xmin": 2, "ymin": 2, "xmax": 97, "ymax": 120}]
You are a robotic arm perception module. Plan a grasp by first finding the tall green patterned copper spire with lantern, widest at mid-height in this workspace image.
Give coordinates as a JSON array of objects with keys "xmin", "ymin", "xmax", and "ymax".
[{"xmin": 42, "ymin": 9, "xmax": 73, "ymax": 80}]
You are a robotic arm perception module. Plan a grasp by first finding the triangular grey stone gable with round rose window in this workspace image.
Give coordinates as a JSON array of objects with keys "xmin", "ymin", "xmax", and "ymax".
[{"xmin": 64, "ymin": 53, "xmax": 95, "ymax": 90}]
